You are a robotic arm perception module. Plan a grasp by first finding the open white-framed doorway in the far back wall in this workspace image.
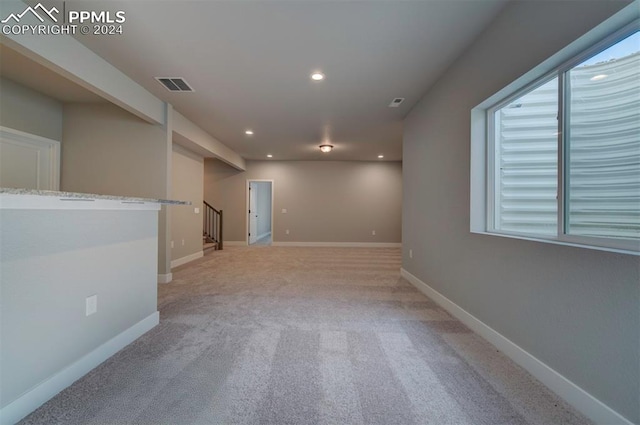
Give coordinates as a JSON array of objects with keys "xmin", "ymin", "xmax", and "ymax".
[{"xmin": 247, "ymin": 180, "xmax": 273, "ymax": 246}]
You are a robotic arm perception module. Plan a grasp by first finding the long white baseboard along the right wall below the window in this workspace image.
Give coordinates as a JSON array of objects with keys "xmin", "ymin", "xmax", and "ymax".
[{"xmin": 400, "ymin": 269, "xmax": 633, "ymax": 425}]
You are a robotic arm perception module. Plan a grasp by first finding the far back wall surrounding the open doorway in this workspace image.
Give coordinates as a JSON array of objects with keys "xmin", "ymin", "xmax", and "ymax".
[{"xmin": 205, "ymin": 160, "xmax": 402, "ymax": 243}]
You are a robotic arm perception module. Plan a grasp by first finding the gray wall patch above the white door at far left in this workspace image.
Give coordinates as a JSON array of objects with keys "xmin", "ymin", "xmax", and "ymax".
[{"xmin": 0, "ymin": 78, "xmax": 62, "ymax": 141}]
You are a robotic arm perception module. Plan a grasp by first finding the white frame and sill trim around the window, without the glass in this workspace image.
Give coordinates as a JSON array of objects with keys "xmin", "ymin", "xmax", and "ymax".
[{"xmin": 470, "ymin": 13, "xmax": 640, "ymax": 256}]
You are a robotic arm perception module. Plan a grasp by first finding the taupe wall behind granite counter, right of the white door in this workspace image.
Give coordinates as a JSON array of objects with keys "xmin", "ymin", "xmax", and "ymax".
[{"xmin": 60, "ymin": 104, "xmax": 172, "ymax": 274}]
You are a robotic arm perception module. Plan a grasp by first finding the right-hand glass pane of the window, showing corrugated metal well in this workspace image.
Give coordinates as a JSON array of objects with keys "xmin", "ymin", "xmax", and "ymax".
[{"xmin": 564, "ymin": 32, "xmax": 640, "ymax": 239}]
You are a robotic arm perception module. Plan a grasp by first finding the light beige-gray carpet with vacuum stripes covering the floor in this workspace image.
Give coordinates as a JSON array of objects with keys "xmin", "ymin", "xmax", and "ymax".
[{"xmin": 22, "ymin": 247, "xmax": 589, "ymax": 425}]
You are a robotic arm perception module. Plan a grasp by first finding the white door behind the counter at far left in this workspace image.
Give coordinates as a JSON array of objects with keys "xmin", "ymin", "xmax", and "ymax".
[{"xmin": 0, "ymin": 127, "xmax": 60, "ymax": 190}]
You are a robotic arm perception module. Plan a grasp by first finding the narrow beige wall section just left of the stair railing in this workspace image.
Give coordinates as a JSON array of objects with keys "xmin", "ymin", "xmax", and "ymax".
[{"xmin": 171, "ymin": 144, "xmax": 204, "ymax": 260}]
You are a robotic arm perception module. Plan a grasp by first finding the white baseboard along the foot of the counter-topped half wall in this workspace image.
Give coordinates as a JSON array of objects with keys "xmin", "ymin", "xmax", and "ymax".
[{"xmin": 0, "ymin": 311, "xmax": 160, "ymax": 425}]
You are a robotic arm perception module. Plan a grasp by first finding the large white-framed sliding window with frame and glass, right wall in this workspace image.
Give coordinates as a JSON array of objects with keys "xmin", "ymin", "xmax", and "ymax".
[{"xmin": 472, "ymin": 21, "xmax": 640, "ymax": 253}]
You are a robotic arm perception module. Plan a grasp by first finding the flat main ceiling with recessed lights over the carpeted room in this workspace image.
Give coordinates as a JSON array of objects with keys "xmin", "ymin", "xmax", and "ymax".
[{"xmin": 22, "ymin": 0, "xmax": 506, "ymax": 160}]
